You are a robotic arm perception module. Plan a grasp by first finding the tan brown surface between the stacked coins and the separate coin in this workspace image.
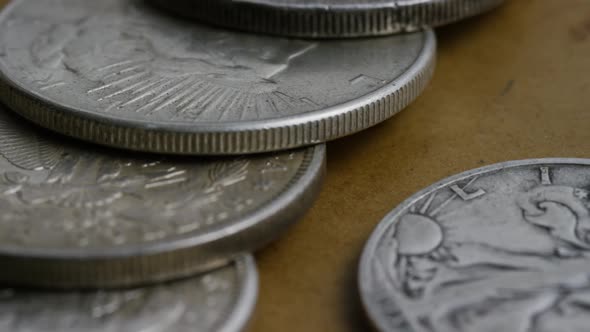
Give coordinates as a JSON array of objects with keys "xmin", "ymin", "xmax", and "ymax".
[{"xmin": 0, "ymin": 0, "xmax": 590, "ymax": 332}]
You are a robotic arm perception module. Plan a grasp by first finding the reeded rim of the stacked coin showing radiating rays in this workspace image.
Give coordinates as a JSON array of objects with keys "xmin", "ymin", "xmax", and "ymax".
[{"xmin": 0, "ymin": 0, "xmax": 436, "ymax": 155}]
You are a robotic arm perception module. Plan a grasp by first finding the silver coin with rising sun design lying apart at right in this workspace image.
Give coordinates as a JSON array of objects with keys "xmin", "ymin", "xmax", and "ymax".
[{"xmin": 360, "ymin": 159, "xmax": 590, "ymax": 332}]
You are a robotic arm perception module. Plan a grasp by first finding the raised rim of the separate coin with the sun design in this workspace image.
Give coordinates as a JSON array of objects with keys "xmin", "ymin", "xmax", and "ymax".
[{"xmin": 357, "ymin": 158, "xmax": 590, "ymax": 331}]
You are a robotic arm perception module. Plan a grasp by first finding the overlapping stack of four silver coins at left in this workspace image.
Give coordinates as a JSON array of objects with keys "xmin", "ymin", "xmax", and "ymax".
[{"xmin": 0, "ymin": 0, "xmax": 501, "ymax": 332}]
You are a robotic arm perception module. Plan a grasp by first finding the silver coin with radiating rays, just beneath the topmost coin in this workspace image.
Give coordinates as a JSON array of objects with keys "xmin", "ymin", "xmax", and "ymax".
[{"xmin": 0, "ymin": 0, "xmax": 436, "ymax": 154}]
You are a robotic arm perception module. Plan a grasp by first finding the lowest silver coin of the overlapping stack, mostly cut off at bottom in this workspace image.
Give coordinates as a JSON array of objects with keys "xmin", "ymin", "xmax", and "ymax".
[{"xmin": 0, "ymin": 255, "xmax": 258, "ymax": 332}]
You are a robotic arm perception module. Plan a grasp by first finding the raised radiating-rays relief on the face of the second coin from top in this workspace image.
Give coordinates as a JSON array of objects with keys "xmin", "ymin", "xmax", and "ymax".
[{"xmin": 30, "ymin": 1, "xmax": 319, "ymax": 121}]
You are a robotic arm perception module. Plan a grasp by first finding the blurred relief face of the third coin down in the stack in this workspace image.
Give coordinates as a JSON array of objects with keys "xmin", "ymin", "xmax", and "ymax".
[{"xmin": 0, "ymin": 113, "xmax": 308, "ymax": 247}]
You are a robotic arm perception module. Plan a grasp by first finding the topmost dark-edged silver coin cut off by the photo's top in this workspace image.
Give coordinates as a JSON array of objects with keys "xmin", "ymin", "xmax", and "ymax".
[{"xmin": 150, "ymin": 0, "xmax": 504, "ymax": 38}]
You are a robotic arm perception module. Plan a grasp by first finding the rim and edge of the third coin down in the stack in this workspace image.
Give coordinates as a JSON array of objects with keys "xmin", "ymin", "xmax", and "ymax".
[{"xmin": 0, "ymin": 141, "xmax": 326, "ymax": 289}]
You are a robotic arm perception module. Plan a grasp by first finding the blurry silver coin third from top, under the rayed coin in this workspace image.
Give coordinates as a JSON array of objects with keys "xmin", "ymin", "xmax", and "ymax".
[{"xmin": 0, "ymin": 104, "xmax": 325, "ymax": 288}]
